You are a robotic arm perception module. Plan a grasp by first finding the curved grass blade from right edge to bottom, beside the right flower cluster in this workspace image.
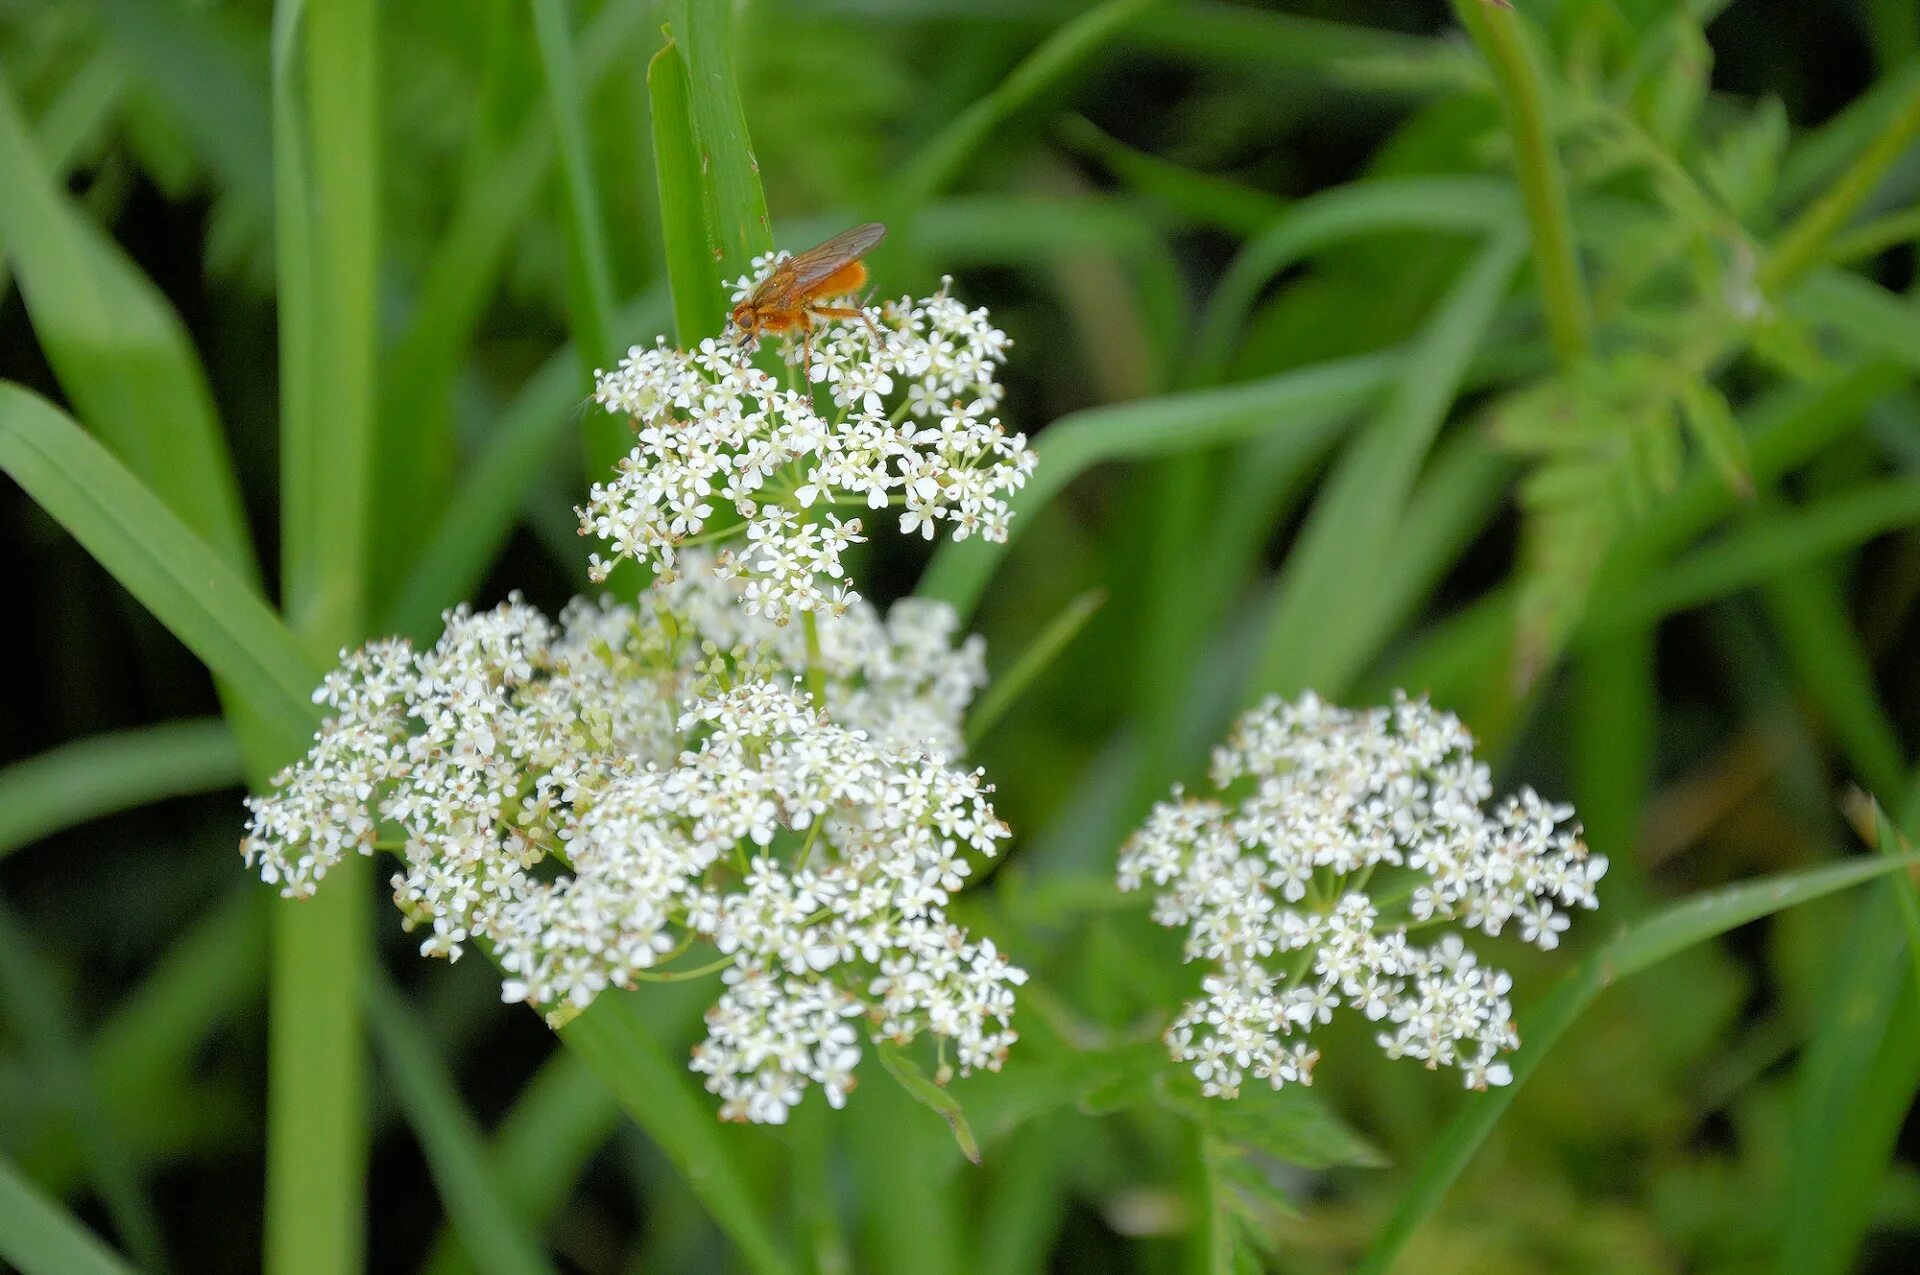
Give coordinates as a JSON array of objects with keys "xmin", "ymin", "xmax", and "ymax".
[{"xmin": 1357, "ymin": 858, "xmax": 1914, "ymax": 1275}]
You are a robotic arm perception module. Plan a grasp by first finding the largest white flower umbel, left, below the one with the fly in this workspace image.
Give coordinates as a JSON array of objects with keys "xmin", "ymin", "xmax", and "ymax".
[{"xmin": 242, "ymin": 553, "xmax": 1025, "ymax": 1123}]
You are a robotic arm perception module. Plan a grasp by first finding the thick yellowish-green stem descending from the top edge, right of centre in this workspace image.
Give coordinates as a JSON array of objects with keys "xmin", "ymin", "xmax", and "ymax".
[{"xmin": 1453, "ymin": 0, "xmax": 1594, "ymax": 363}]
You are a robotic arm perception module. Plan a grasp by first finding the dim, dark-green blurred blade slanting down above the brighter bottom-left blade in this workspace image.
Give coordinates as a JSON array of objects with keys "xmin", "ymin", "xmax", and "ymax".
[{"xmin": 0, "ymin": 908, "xmax": 167, "ymax": 1271}]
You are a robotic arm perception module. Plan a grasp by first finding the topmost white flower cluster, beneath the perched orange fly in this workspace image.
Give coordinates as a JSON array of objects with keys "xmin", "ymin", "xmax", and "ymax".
[{"xmin": 580, "ymin": 274, "xmax": 1033, "ymax": 620}]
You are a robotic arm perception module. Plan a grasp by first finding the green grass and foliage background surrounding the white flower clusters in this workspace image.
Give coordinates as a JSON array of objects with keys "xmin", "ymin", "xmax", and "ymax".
[{"xmin": 0, "ymin": 0, "xmax": 1920, "ymax": 1275}]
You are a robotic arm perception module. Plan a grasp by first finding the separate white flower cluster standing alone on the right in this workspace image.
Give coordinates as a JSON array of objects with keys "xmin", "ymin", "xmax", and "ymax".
[{"xmin": 1119, "ymin": 693, "xmax": 1607, "ymax": 1096}]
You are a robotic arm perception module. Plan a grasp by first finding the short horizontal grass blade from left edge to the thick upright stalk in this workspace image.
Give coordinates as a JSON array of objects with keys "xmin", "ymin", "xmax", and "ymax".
[{"xmin": 0, "ymin": 720, "xmax": 240, "ymax": 858}]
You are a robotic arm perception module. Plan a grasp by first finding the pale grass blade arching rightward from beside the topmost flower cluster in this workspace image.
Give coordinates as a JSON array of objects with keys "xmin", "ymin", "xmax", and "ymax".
[{"xmin": 918, "ymin": 355, "xmax": 1398, "ymax": 618}]
